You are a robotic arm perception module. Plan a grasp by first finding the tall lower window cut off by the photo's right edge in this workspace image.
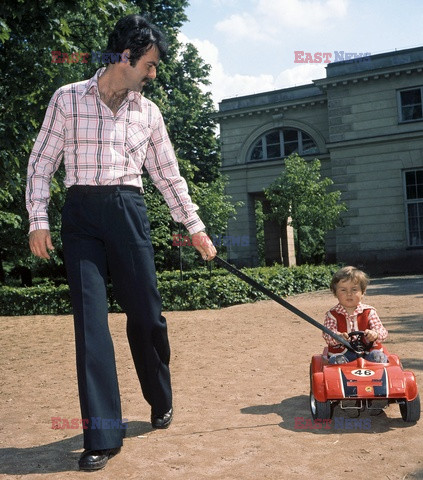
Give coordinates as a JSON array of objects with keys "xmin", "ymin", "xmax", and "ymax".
[{"xmin": 404, "ymin": 169, "xmax": 423, "ymax": 247}]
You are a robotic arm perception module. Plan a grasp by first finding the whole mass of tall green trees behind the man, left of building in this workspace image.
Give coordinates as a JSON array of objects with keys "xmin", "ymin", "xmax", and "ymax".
[{"xmin": 0, "ymin": 0, "xmax": 237, "ymax": 281}]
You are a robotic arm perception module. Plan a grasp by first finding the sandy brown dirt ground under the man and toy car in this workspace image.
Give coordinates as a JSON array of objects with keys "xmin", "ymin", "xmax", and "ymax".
[{"xmin": 0, "ymin": 276, "xmax": 423, "ymax": 480}]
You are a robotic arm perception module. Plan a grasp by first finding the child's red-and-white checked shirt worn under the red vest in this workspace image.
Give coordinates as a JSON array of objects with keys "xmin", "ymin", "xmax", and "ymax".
[{"xmin": 323, "ymin": 303, "xmax": 388, "ymax": 346}]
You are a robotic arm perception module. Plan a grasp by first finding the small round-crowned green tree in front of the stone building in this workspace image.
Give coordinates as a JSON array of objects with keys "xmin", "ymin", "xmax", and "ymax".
[{"xmin": 265, "ymin": 154, "xmax": 346, "ymax": 264}]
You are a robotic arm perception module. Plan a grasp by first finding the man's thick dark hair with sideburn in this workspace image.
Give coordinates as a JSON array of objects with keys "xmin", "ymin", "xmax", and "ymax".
[{"xmin": 106, "ymin": 15, "xmax": 167, "ymax": 67}]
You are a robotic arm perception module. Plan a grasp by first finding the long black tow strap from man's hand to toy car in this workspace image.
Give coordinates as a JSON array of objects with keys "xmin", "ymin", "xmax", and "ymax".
[{"xmin": 214, "ymin": 256, "xmax": 355, "ymax": 352}]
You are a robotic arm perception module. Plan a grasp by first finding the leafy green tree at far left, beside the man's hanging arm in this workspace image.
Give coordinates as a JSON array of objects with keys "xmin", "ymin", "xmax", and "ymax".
[{"xmin": 0, "ymin": 0, "xmax": 125, "ymax": 280}]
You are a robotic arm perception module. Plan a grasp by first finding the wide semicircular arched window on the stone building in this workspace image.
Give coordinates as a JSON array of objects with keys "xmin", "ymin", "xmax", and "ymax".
[{"xmin": 249, "ymin": 128, "xmax": 318, "ymax": 162}]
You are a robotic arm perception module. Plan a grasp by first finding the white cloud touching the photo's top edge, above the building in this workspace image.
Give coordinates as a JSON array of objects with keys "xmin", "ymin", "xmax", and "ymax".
[{"xmin": 215, "ymin": 0, "xmax": 349, "ymax": 41}]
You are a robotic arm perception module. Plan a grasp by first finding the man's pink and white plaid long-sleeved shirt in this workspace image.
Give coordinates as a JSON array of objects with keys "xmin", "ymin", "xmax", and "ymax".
[{"xmin": 26, "ymin": 68, "xmax": 204, "ymax": 234}]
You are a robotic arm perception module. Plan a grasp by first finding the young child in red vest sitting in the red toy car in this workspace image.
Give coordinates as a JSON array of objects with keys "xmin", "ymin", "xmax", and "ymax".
[{"xmin": 323, "ymin": 267, "xmax": 388, "ymax": 363}]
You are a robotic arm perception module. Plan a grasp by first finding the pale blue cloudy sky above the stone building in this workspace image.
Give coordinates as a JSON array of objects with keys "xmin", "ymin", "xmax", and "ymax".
[{"xmin": 180, "ymin": 0, "xmax": 423, "ymax": 104}]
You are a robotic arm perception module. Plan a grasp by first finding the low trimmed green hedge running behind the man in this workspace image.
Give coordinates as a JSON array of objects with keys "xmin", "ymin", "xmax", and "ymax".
[{"xmin": 0, "ymin": 265, "xmax": 339, "ymax": 316}]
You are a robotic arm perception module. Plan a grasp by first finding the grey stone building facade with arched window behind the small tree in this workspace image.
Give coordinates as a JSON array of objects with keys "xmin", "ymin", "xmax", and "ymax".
[{"xmin": 218, "ymin": 47, "xmax": 423, "ymax": 273}]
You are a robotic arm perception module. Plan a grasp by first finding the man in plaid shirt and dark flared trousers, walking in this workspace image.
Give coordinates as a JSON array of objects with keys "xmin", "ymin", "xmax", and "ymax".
[{"xmin": 27, "ymin": 15, "xmax": 216, "ymax": 470}]
